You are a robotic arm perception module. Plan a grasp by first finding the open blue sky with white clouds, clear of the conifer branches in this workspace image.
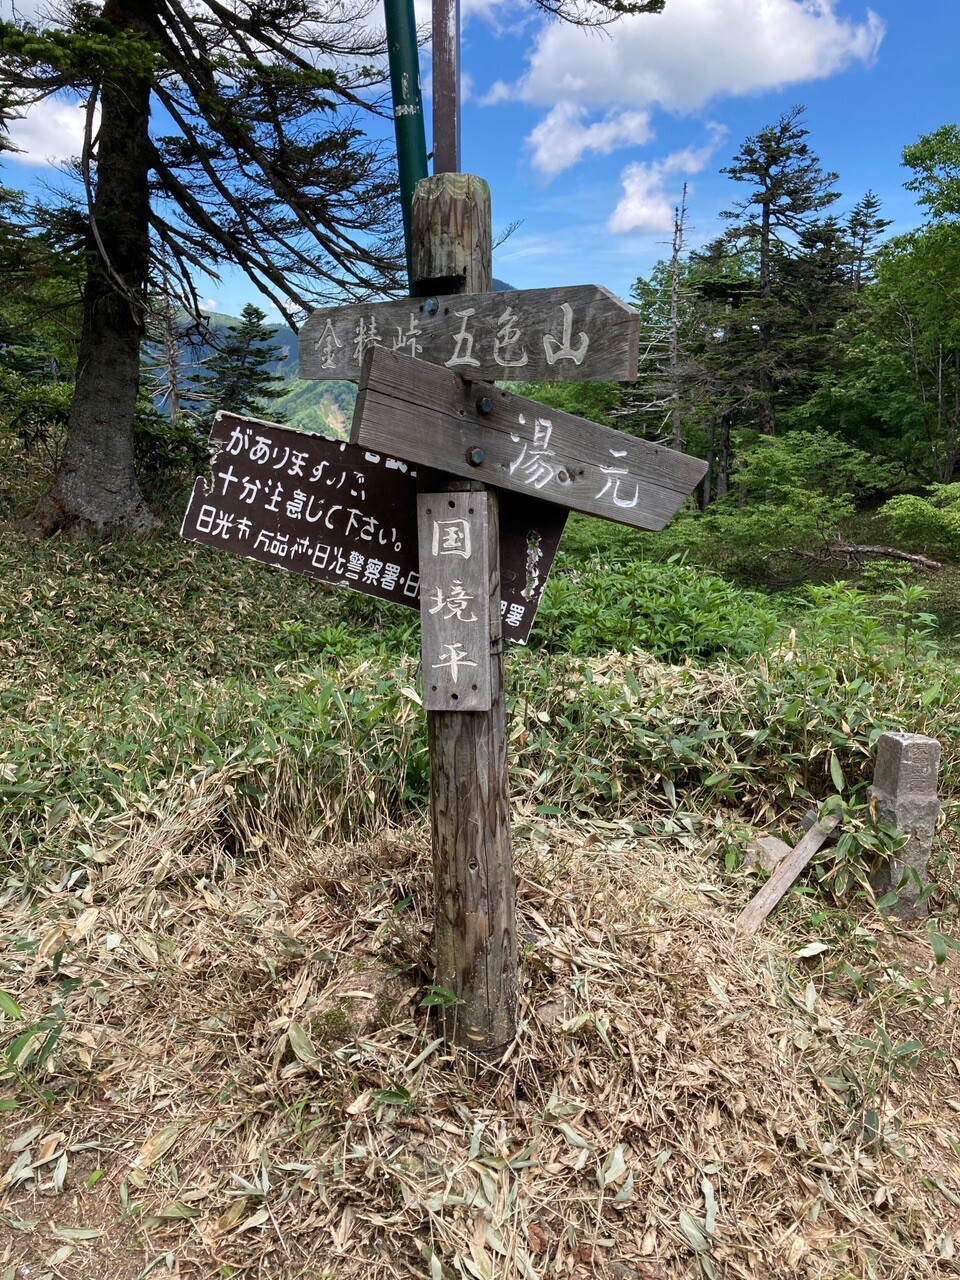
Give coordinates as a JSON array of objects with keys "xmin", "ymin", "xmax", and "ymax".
[{"xmin": 0, "ymin": 0, "xmax": 960, "ymax": 314}]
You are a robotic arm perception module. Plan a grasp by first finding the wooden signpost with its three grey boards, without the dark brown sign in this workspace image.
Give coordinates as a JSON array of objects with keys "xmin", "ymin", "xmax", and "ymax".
[{"xmin": 301, "ymin": 177, "xmax": 707, "ymax": 1061}]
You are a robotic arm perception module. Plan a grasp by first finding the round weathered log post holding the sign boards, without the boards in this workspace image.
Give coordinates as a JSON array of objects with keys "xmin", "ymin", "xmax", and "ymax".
[{"xmin": 412, "ymin": 173, "xmax": 517, "ymax": 1061}]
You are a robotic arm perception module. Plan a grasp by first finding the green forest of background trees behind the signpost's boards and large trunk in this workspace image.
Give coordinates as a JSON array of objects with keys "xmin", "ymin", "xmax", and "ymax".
[{"xmin": 9, "ymin": 108, "xmax": 960, "ymax": 596}]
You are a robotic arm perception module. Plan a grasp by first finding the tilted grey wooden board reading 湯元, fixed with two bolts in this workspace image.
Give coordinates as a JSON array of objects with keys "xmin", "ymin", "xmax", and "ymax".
[{"xmin": 351, "ymin": 347, "xmax": 707, "ymax": 530}]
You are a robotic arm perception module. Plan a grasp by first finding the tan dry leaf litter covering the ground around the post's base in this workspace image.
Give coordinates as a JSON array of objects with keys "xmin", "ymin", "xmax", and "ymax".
[{"xmin": 0, "ymin": 776, "xmax": 960, "ymax": 1280}]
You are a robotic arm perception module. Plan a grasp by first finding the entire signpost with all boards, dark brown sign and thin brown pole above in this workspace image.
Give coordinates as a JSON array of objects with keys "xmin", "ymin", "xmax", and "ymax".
[{"xmin": 183, "ymin": 0, "xmax": 707, "ymax": 1061}]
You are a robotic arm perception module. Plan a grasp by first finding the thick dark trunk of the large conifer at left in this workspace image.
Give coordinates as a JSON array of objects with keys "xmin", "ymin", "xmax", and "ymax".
[{"xmin": 36, "ymin": 0, "xmax": 159, "ymax": 534}]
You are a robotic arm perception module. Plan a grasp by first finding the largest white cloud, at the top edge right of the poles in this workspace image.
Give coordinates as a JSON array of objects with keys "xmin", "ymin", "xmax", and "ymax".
[{"xmin": 504, "ymin": 0, "xmax": 886, "ymax": 111}]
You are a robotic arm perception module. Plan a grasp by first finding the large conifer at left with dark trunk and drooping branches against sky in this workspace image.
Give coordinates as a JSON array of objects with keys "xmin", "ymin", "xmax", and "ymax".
[{"xmin": 0, "ymin": 0, "xmax": 662, "ymax": 532}]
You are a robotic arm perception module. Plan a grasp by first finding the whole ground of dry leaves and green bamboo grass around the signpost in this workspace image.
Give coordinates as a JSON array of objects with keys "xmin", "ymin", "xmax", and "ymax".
[{"xmin": 0, "ymin": 483, "xmax": 960, "ymax": 1280}]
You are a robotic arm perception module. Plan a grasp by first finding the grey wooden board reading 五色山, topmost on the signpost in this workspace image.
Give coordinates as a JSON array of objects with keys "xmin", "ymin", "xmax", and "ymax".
[{"xmin": 298, "ymin": 284, "xmax": 640, "ymax": 383}]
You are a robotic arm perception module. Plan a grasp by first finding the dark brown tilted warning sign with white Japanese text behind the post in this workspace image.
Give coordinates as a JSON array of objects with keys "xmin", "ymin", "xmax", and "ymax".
[{"xmin": 180, "ymin": 413, "xmax": 566, "ymax": 643}]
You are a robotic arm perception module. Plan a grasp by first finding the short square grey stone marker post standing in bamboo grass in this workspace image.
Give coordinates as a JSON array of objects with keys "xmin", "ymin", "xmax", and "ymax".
[{"xmin": 870, "ymin": 733, "xmax": 940, "ymax": 919}]
